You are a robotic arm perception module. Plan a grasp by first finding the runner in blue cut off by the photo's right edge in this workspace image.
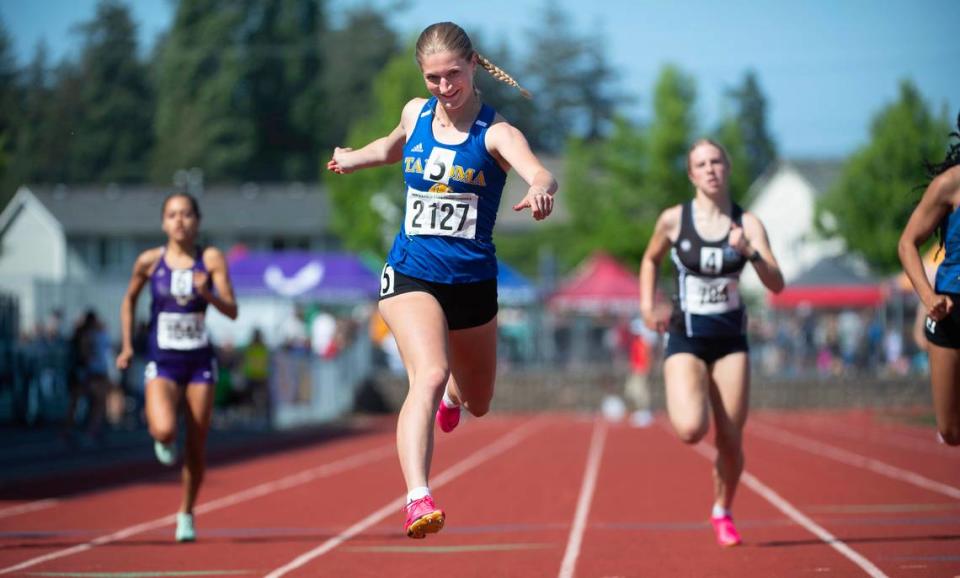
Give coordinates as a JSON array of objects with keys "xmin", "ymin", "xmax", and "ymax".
[{"xmin": 898, "ymin": 115, "xmax": 960, "ymax": 446}]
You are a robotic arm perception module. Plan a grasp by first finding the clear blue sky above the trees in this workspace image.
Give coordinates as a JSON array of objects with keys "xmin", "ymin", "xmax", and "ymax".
[{"xmin": 0, "ymin": 0, "xmax": 960, "ymax": 157}]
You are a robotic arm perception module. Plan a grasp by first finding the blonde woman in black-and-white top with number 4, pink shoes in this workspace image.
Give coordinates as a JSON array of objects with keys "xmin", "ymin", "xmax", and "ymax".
[{"xmin": 640, "ymin": 139, "xmax": 783, "ymax": 546}]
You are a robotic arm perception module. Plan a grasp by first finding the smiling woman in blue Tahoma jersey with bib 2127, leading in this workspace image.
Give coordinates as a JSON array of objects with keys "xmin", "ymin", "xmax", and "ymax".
[{"xmin": 327, "ymin": 22, "xmax": 557, "ymax": 538}]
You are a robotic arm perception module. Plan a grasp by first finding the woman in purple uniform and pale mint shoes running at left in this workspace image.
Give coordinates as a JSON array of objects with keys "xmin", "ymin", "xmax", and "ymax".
[{"xmin": 117, "ymin": 193, "xmax": 237, "ymax": 542}]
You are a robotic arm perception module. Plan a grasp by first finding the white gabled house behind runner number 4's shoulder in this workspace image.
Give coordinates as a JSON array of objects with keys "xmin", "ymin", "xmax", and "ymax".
[{"xmin": 742, "ymin": 160, "xmax": 845, "ymax": 293}]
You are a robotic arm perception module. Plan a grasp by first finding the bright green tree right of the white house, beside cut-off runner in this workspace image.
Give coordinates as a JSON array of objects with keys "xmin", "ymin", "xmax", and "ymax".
[{"xmin": 817, "ymin": 81, "xmax": 950, "ymax": 273}]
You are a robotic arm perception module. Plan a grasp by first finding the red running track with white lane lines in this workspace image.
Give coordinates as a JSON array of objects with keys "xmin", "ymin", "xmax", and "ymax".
[{"xmin": 0, "ymin": 411, "xmax": 960, "ymax": 578}]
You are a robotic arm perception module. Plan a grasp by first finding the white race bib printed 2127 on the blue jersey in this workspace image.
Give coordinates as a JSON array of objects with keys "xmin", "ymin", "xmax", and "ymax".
[{"xmin": 404, "ymin": 189, "xmax": 479, "ymax": 239}]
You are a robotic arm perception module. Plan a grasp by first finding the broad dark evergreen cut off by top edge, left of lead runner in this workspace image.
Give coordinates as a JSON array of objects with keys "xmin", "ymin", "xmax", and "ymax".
[{"xmin": 153, "ymin": 0, "xmax": 326, "ymax": 182}]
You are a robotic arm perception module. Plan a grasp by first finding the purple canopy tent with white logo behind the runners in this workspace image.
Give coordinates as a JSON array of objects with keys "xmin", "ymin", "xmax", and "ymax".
[{"xmin": 230, "ymin": 251, "xmax": 380, "ymax": 302}]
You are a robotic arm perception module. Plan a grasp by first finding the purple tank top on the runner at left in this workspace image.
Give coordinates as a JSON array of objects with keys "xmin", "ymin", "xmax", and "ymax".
[{"xmin": 149, "ymin": 247, "xmax": 213, "ymax": 361}]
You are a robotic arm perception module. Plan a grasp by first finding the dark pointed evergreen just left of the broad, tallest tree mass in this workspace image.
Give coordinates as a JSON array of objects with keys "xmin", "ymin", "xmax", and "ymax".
[{"xmin": 69, "ymin": 0, "xmax": 153, "ymax": 182}]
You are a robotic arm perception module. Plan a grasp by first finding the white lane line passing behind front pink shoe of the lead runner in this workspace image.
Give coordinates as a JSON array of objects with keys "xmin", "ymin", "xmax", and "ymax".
[{"xmin": 264, "ymin": 420, "xmax": 543, "ymax": 578}]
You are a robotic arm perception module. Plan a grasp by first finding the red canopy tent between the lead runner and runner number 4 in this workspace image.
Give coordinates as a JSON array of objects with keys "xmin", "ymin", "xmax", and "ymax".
[{"xmin": 549, "ymin": 252, "xmax": 640, "ymax": 315}]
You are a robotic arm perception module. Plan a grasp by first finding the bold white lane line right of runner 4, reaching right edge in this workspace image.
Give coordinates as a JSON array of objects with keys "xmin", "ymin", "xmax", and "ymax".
[{"xmin": 748, "ymin": 424, "xmax": 960, "ymax": 500}]
